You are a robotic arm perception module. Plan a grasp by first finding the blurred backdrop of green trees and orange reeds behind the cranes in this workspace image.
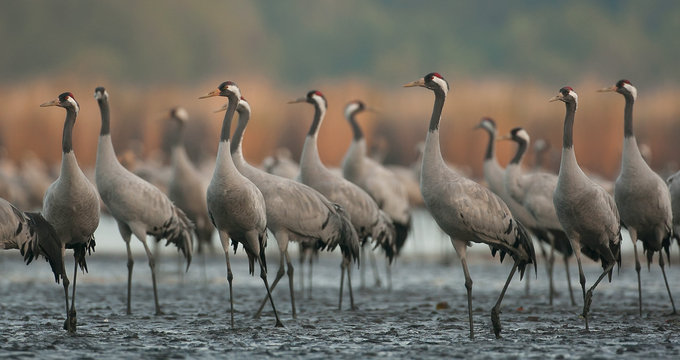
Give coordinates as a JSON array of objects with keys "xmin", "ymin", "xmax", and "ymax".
[{"xmin": 0, "ymin": 0, "xmax": 680, "ymax": 211}]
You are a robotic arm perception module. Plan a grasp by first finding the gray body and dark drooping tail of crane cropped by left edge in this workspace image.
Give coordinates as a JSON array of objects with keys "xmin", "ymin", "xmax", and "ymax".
[{"xmin": 0, "ymin": 198, "xmax": 64, "ymax": 283}]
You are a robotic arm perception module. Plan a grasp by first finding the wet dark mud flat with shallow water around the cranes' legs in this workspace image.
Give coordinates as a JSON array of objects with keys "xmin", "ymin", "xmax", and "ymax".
[{"xmin": 0, "ymin": 249, "xmax": 680, "ymax": 359}]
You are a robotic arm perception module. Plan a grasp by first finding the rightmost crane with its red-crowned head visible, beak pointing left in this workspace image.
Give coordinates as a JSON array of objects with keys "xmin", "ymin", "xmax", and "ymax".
[{"xmin": 600, "ymin": 80, "xmax": 676, "ymax": 316}]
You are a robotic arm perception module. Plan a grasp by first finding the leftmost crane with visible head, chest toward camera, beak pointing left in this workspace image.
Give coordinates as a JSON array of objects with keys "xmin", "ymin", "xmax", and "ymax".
[{"xmin": 40, "ymin": 92, "xmax": 99, "ymax": 332}]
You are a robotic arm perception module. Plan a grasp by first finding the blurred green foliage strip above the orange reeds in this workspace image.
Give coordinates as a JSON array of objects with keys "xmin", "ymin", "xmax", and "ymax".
[{"xmin": 0, "ymin": 0, "xmax": 680, "ymax": 86}]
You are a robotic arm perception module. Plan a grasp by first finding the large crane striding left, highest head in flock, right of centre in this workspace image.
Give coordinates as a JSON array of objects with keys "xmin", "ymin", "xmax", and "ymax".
[{"xmin": 404, "ymin": 73, "xmax": 536, "ymax": 338}]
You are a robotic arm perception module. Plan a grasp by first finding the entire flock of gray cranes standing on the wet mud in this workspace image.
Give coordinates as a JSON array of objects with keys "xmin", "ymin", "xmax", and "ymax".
[{"xmin": 0, "ymin": 73, "xmax": 680, "ymax": 338}]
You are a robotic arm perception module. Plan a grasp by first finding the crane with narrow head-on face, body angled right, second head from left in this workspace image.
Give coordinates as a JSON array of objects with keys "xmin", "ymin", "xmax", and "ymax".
[{"xmin": 94, "ymin": 87, "xmax": 194, "ymax": 315}]
